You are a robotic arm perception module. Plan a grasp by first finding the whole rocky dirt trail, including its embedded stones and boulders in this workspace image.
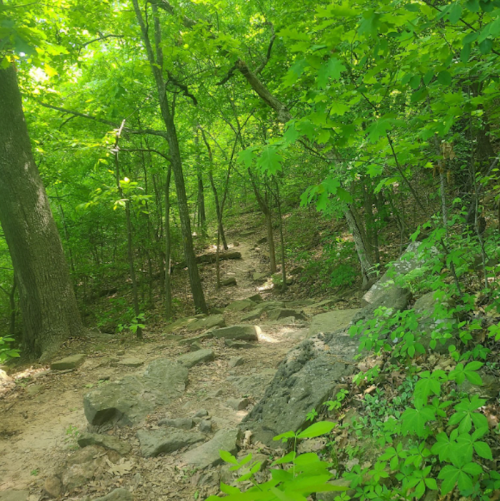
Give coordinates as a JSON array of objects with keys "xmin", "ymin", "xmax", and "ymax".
[{"xmin": 0, "ymin": 228, "xmax": 426, "ymax": 501}]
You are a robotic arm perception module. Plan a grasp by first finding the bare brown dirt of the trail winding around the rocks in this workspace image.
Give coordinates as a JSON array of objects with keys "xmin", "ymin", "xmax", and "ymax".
[{"xmin": 0, "ymin": 229, "xmax": 352, "ymax": 501}]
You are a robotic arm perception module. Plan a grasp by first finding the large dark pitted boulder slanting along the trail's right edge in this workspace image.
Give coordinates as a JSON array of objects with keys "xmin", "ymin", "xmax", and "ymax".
[{"xmin": 243, "ymin": 331, "xmax": 358, "ymax": 446}]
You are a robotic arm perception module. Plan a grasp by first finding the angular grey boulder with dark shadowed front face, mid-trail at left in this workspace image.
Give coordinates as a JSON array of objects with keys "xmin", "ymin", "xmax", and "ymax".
[{"xmin": 83, "ymin": 359, "xmax": 188, "ymax": 426}]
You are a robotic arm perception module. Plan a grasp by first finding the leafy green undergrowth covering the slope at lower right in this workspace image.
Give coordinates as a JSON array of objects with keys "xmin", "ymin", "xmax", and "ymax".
[{"xmin": 209, "ymin": 205, "xmax": 500, "ymax": 501}]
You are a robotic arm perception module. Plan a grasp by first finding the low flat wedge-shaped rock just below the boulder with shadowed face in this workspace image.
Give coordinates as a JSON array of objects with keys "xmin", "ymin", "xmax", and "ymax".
[{"xmin": 137, "ymin": 428, "xmax": 205, "ymax": 458}]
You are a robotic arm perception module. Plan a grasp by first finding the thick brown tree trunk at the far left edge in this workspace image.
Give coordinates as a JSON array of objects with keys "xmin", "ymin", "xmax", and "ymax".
[{"xmin": 0, "ymin": 66, "xmax": 83, "ymax": 360}]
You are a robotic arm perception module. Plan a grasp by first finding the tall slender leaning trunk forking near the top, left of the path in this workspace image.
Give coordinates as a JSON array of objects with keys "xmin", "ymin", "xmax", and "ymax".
[{"xmin": 133, "ymin": 0, "xmax": 208, "ymax": 313}]
